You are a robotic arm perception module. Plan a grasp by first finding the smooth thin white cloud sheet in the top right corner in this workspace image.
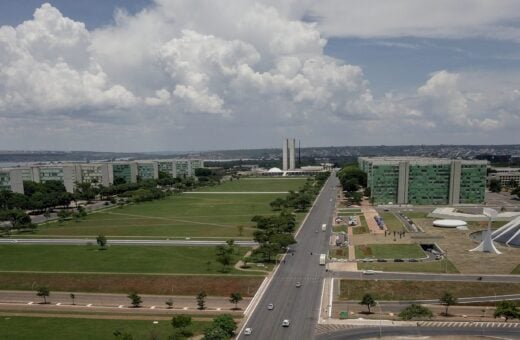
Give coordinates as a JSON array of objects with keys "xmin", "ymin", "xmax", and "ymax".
[{"xmin": 307, "ymin": 0, "xmax": 520, "ymax": 42}]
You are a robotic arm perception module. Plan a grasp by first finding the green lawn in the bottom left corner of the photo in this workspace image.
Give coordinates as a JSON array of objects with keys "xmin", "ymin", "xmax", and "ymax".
[{"xmin": 0, "ymin": 316, "xmax": 210, "ymax": 340}]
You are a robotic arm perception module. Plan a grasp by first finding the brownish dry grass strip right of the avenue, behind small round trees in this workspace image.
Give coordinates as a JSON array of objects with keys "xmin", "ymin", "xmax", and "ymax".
[{"xmin": 340, "ymin": 280, "xmax": 520, "ymax": 301}]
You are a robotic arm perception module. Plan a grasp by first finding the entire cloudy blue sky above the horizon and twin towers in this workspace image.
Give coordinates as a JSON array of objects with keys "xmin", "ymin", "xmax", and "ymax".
[{"xmin": 0, "ymin": 0, "xmax": 520, "ymax": 151}]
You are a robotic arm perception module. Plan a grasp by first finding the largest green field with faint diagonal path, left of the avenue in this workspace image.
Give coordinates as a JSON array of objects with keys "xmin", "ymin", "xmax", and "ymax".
[{"xmin": 36, "ymin": 194, "xmax": 303, "ymax": 239}]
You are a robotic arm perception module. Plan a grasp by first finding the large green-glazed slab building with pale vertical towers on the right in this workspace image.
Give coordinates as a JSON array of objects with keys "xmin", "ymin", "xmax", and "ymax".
[{"xmin": 358, "ymin": 157, "xmax": 487, "ymax": 205}]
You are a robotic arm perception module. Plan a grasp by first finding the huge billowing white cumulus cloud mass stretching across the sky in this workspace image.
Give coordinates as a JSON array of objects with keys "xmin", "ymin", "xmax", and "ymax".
[{"xmin": 0, "ymin": 0, "xmax": 520, "ymax": 148}]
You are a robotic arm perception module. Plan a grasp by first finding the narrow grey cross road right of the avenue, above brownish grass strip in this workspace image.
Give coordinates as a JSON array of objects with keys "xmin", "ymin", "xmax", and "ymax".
[{"xmin": 331, "ymin": 271, "xmax": 520, "ymax": 282}]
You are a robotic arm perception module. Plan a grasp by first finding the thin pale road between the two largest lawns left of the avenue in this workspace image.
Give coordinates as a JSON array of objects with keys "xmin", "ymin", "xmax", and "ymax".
[{"xmin": 0, "ymin": 238, "xmax": 257, "ymax": 247}]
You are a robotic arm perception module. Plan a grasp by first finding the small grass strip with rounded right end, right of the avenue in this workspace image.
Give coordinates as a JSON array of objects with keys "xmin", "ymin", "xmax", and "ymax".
[{"xmin": 358, "ymin": 260, "xmax": 459, "ymax": 273}]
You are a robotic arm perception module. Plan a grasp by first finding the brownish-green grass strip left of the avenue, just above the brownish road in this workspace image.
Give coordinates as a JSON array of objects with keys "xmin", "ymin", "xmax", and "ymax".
[{"xmin": 0, "ymin": 272, "xmax": 264, "ymax": 298}]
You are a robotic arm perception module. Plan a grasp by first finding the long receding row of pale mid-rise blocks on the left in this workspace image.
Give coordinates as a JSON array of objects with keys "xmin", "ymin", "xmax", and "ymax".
[{"xmin": 0, "ymin": 159, "xmax": 204, "ymax": 193}]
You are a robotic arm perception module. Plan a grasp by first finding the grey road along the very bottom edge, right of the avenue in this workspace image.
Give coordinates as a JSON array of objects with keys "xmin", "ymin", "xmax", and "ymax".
[{"xmin": 316, "ymin": 327, "xmax": 520, "ymax": 340}]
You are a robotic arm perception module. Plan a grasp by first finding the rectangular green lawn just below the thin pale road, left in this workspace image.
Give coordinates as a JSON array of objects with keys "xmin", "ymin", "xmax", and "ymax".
[{"xmin": 0, "ymin": 241, "xmax": 248, "ymax": 274}]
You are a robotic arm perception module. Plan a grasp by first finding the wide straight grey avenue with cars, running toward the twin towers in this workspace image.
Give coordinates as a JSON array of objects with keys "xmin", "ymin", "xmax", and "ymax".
[{"xmin": 239, "ymin": 175, "xmax": 339, "ymax": 340}]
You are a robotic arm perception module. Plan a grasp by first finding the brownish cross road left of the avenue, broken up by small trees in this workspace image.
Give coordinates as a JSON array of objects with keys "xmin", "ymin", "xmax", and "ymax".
[{"xmin": 0, "ymin": 291, "xmax": 251, "ymax": 310}]
